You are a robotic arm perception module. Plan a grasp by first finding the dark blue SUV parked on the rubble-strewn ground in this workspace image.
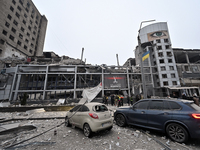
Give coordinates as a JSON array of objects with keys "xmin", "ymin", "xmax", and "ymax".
[{"xmin": 114, "ymin": 99, "xmax": 200, "ymax": 143}]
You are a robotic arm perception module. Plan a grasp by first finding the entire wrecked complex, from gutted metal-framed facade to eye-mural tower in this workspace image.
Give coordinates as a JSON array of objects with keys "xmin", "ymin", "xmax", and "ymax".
[{"xmin": 0, "ymin": 22, "xmax": 200, "ymax": 101}]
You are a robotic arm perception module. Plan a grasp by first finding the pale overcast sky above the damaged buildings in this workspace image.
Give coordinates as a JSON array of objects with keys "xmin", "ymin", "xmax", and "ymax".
[{"xmin": 32, "ymin": 0, "xmax": 200, "ymax": 65}]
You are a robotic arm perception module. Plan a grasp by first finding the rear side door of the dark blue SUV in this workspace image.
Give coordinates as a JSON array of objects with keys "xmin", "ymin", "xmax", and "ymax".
[{"xmin": 146, "ymin": 100, "xmax": 173, "ymax": 130}]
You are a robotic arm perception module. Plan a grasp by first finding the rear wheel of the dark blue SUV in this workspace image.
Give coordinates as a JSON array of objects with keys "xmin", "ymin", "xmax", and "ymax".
[{"xmin": 166, "ymin": 123, "xmax": 188, "ymax": 143}]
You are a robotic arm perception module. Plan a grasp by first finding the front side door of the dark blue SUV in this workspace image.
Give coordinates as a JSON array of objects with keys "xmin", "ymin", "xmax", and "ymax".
[{"xmin": 128, "ymin": 100, "xmax": 149, "ymax": 126}]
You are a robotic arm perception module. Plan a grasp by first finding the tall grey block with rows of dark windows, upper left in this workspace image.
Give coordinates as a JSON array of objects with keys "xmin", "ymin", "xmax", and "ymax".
[{"xmin": 0, "ymin": 0, "xmax": 47, "ymax": 58}]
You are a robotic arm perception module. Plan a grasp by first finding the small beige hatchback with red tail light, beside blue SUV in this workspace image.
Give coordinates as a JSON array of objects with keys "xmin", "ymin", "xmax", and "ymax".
[{"xmin": 65, "ymin": 102, "xmax": 113, "ymax": 137}]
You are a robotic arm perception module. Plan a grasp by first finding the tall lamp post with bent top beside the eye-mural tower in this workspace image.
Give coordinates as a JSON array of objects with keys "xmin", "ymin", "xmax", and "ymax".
[{"xmin": 138, "ymin": 20, "xmax": 156, "ymax": 98}]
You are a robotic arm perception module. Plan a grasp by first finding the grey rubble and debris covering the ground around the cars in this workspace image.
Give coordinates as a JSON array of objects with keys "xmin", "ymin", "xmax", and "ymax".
[{"xmin": 0, "ymin": 106, "xmax": 200, "ymax": 150}]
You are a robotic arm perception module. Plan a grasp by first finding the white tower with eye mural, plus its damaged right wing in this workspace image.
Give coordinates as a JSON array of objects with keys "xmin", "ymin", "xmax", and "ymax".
[{"xmin": 135, "ymin": 22, "xmax": 200, "ymax": 97}]
